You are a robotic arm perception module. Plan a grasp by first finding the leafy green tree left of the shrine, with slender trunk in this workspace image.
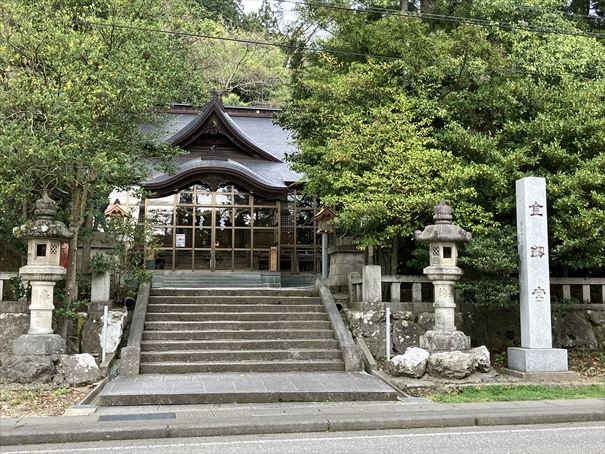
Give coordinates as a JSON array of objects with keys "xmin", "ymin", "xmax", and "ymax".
[{"xmin": 0, "ymin": 0, "xmax": 209, "ymax": 300}]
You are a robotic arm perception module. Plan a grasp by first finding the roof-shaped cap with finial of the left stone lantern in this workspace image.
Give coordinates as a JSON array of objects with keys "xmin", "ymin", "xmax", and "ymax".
[{"xmin": 13, "ymin": 191, "xmax": 74, "ymax": 240}]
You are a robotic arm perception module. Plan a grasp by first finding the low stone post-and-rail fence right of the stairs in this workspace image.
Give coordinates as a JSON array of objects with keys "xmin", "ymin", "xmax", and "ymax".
[{"xmin": 349, "ymin": 272, "xmax": 605, "ymax": 304}]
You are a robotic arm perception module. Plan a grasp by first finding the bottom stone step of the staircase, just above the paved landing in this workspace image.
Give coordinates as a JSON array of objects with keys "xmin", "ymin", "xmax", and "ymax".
[{"xmin": 140, "ymin": 359, "xmax": 344, "ymax": 374}]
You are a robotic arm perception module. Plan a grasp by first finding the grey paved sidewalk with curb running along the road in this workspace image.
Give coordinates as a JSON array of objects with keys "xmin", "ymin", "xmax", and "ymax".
[{"xmin": 0, "ymin": 399, "xmax": 605, "ymax": 445}]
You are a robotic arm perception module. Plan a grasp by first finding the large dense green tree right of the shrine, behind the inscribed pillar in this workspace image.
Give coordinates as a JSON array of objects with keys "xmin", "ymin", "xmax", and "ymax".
[{"xmin": 282, "ymin": 0, "xmax": 605, "ymax": 286}]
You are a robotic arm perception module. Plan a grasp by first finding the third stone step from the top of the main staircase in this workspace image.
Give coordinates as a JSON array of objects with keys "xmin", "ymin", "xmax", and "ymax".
[{"xmin": 147, "ymin": 303, "xmax": 325, "ymax": 313}]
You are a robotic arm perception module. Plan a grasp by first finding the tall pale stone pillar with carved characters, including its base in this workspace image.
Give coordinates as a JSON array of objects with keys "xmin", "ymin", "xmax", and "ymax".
[{"xmin": 508, "ymin": 177, "xmax": 567, "ymax": 372}]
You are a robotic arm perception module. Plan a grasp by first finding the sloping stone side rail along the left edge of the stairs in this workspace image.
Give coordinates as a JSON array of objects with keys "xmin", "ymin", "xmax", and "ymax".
[{"xmin": 120, "ymin": 282, "xmax": 151, "ymax": 375}]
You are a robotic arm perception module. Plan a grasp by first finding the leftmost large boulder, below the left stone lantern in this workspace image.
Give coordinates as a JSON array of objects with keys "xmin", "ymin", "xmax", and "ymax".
[{"xmin": 0, "ymin": 355, "xmax": 56, "ymax": 384}]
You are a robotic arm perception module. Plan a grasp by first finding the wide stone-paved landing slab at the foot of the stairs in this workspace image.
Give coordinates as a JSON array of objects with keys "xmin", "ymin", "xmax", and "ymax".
[{"xmin": 100, "ymin": 372, "xmax": 397, "ymax": 406}]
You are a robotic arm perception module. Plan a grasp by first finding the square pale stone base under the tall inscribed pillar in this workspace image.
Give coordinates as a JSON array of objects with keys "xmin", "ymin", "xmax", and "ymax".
[{"xmin": 508, "ymin": 347, "xmax": 568, "ymax": 372}]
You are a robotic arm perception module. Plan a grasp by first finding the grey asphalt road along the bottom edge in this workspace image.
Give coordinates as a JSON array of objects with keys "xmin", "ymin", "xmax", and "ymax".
[{"xmin": 0, "ymin": 423, "xmax": 605, "ymax": 454}]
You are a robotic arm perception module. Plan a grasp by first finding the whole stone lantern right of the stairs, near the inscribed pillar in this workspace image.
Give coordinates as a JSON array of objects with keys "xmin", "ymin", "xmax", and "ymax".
[{"xmin": 416, "ymin": 199, "xmax": 471, "ymax": 352}]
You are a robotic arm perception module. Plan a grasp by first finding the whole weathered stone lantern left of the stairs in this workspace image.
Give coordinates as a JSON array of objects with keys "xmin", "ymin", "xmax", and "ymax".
[{"xmin": 13, "ymin": 192, "xmax": 73, "ymax": 355}]
